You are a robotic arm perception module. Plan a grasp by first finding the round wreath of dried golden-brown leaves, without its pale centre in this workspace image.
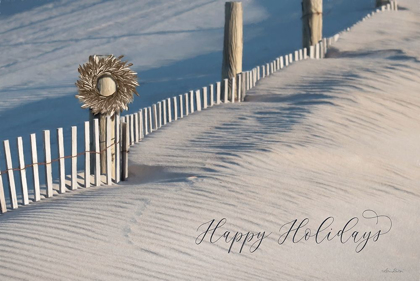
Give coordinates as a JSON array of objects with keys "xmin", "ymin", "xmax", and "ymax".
[{"xmin": 76, "ymin": 55, "xmax": 139, "ymax": 116}]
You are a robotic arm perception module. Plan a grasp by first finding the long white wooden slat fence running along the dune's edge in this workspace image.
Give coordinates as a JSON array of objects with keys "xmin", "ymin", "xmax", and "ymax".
[{"xmin": 0, "ymin": 1, "xmax": 398, "ymax": 213}]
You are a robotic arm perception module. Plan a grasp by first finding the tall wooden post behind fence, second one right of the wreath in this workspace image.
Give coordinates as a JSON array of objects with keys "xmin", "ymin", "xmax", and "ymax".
[{"xmin": 302, "ymin": 0, "xmax": 322, "ymax": 50}]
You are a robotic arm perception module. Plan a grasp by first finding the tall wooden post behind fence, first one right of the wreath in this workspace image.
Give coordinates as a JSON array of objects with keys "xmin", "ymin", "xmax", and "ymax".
[{"xmin": 222, "ymin": 2, "xmax": 244, "ymax": 100}]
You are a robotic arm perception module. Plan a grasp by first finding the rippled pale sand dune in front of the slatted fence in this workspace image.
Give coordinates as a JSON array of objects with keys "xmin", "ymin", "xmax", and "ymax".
[{"xmin": 0, "ymin": 0, "xmax": 420, "ymax": 280}]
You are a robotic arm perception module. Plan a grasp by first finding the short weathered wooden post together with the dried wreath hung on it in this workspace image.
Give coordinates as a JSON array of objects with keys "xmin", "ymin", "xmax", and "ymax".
[{"xmin": 76, "ymin": 55, "xmax": 139, "ymax": 182}]
